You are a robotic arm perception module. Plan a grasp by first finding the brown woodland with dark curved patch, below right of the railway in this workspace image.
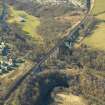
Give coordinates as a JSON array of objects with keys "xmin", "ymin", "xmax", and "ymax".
[{"xmin": 4, "ymin": 46, "xmax": 105, "ymax": 105}]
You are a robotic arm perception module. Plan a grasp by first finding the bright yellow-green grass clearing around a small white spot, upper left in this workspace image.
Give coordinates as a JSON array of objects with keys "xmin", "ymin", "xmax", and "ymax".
[{"xmin": 8, "ymin": 7, "xmax": 43, "ymax": 44}]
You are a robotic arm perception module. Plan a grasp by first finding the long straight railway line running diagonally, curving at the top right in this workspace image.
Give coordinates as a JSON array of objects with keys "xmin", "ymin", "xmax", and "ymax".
[{"xmin": 0, "ymin": 0, "xmax": 92, "ymax": 105}]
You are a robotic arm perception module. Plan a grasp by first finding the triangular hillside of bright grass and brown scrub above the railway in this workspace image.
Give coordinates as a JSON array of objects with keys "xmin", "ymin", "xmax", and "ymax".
[{"xmin": 8, "ymin": 1, "xmax": 84, "ymax": 53}]
